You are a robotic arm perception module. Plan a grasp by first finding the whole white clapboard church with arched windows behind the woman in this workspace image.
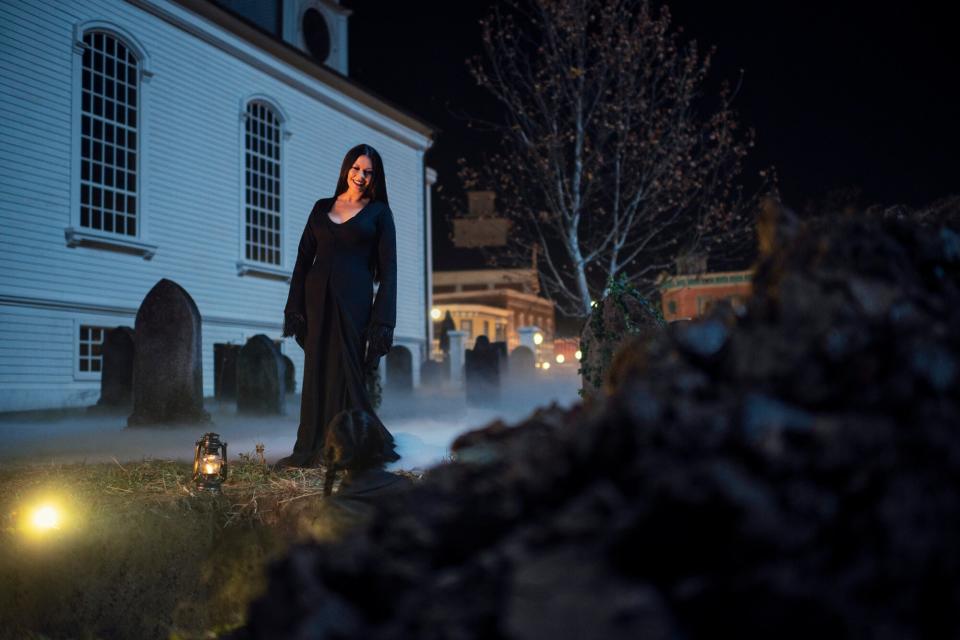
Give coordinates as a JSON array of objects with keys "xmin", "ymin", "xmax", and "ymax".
[{"xmin": 0, "ymin": 0, "xmax": 433, "ymax": 411}]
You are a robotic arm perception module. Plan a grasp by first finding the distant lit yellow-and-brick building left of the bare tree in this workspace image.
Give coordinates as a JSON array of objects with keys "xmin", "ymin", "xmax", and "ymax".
[{"xmin": 433, "ymin": 268, "xmax": 555, "ymax": 357}]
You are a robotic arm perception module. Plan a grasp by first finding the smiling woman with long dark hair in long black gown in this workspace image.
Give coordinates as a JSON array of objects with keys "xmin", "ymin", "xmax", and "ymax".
[{"xmin": 277, "ymin": 144, "xmax": 400, "ymax": 467}]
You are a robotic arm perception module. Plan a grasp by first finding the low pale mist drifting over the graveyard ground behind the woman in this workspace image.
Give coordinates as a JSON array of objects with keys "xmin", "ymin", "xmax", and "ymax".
[{"xmin": 0, "ymin": 367, "xmax": 580, "ymax": 470}]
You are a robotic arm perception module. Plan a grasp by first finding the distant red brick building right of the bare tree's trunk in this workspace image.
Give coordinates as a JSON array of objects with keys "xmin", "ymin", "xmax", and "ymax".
[{"xmin": 660, "ymin": 270, "xmax": 753, "ymax": 321}]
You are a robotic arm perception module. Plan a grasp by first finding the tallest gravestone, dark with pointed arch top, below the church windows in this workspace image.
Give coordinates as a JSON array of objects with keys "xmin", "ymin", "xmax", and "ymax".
[{"xmin": 127, "ymin": 278, "xmax": 210, "ymax": 427}]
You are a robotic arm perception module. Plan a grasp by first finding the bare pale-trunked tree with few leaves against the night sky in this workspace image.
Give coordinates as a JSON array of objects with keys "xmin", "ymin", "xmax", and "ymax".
[{"xmin": 459, "ymin": 0, "xmax": 772, "ymax": 316}]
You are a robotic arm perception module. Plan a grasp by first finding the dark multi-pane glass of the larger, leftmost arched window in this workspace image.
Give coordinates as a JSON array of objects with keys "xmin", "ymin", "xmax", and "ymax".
[{"xmin": 80, "ymin": 30, "xmax": 140, "ymax": 236}]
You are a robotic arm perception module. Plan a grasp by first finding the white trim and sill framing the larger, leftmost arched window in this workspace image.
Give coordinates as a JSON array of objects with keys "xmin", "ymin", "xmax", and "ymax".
[{"xmin": 64, "ymin": 20, "xmax": 157, "ymax": 260}]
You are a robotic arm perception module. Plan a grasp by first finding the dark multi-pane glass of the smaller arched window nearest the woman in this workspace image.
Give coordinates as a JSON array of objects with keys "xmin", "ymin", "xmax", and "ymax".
[{"xmin": 244, "ymin": 100, "xmax": 283, "ymax": 266}]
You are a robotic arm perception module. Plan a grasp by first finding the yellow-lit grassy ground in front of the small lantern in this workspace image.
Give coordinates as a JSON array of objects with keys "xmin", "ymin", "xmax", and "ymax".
[{"xmin": 0, "ymin": 455, "xmax": 416, "ymax": 639}]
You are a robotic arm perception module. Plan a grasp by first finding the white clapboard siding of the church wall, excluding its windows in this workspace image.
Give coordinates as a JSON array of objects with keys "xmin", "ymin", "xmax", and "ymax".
[{"xmin": 0, "ymin": 0, "xmax": 429, "ymax": 411}]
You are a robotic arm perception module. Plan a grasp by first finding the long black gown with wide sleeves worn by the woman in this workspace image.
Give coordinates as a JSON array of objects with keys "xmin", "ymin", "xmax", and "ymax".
[{"xmin": 284, "ymin": 198, "xmax": 400, "ymax": 466}]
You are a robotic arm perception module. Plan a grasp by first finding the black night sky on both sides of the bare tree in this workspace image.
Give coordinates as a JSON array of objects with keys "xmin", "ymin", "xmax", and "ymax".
[{"xmin": 342, "ymin": 0, "xmax": 960, "ymax": 269}]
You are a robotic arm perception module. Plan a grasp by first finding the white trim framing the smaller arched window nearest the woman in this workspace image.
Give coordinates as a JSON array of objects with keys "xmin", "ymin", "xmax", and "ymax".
[{"xmin": 236, "ymin": 93, "xmax": 293, "ymax": 282}]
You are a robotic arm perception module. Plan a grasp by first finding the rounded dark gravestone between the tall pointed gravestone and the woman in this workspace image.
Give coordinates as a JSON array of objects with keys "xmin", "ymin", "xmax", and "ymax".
[{"xmin": 237, "ymin": 333, "xmax": 287, "ymax": 415}]
